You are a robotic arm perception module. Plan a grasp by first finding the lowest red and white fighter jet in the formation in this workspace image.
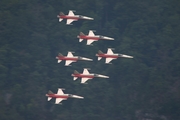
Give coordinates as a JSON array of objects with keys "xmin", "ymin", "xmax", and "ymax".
[{"xmin": 46, "ymin": 88, "xmax": 84, "ymax": 104}]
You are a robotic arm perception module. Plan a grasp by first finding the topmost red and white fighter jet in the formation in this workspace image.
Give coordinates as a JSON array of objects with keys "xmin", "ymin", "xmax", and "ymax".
[{"xmin": 57, "ymin": 10, "xmax": 94, "ymax": 25}]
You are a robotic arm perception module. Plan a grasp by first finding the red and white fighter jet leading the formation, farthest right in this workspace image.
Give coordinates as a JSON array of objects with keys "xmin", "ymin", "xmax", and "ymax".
[{"xmin": 96, "ymin": 48, "xmax": 133, "ymax": 63}]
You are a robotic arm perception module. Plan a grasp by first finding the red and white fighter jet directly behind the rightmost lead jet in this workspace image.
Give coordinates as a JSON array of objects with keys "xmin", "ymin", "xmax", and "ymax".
[{"xmin": 56, "ymin": 52, "xmax": 93, "ymax": 66}]
